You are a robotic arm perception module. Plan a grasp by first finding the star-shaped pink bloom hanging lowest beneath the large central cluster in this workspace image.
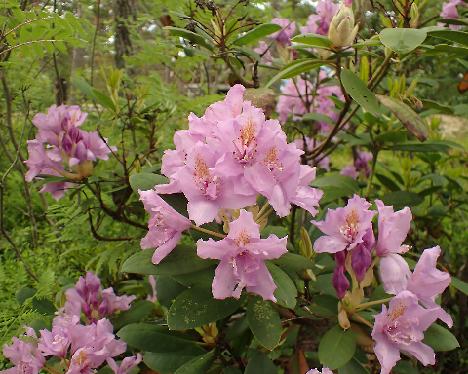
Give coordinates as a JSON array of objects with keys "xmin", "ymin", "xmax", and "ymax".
[{"xmin": 197, "ymin": 209, "xmax": 287, "ymax": 301}]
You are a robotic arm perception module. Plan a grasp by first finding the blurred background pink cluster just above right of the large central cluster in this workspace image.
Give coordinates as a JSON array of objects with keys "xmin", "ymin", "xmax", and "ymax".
[{"xmin": 276, "ymin": 72, "xmax": 344, "ymax": 132}]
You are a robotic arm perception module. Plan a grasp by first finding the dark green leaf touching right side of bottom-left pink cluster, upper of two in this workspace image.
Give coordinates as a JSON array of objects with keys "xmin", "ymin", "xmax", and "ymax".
[{"xmin": 117, "ymin": 323, "xmax": 206, "ymax": 356}]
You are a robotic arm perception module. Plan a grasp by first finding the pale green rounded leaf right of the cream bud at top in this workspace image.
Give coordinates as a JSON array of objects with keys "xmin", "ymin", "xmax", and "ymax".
[{"xmin": 379, "ymin": 28, "xmax": 427, "ymax": 54}]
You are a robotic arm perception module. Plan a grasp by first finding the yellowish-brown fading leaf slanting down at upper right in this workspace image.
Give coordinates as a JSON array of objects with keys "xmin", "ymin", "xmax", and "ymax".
[{"xmin": 377, "ymin": 95, "xmax": 429, "ymax": 141}]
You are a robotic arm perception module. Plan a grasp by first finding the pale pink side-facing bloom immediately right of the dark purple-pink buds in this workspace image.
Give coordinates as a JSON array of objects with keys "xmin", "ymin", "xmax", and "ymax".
[{"xmin": 375, "ymin": 200, "xmax": 411, "ymax": 294}]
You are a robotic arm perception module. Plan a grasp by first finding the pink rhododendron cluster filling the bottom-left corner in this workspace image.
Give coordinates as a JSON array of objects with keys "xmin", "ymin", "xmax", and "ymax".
[{"xmin": 1, "ymin": 273, "xmax": 141, "ymax": 374}]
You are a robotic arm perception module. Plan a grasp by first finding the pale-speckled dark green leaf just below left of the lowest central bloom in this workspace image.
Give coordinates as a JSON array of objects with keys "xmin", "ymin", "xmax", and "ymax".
[{"xmin": 167, "ymin": 287, "xmax": 241, "ymax": 330}]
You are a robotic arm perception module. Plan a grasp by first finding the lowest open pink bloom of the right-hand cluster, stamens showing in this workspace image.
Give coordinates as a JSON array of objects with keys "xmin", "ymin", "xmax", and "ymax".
[{"xmin": 372, "ymin": 291, "xmax": 437, "ymax": 374}]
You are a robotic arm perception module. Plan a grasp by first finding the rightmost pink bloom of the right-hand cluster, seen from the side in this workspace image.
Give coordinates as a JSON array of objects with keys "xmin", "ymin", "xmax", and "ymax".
[{"xmin": 407, "ymin": 246, "xmax": 453, "ymax": 327}]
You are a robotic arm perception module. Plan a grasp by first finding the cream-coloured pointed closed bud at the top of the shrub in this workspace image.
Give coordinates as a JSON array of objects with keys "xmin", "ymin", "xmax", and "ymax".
[{"xmin": 328, "ymin": 5, "xmax": 359, "ymax": 48}]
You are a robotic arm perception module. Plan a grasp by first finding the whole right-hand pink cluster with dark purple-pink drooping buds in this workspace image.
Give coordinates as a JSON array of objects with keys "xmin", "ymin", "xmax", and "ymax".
[{"xmin": 313, "ymin": 195, "xmax": 453, "ymax": 374}]
